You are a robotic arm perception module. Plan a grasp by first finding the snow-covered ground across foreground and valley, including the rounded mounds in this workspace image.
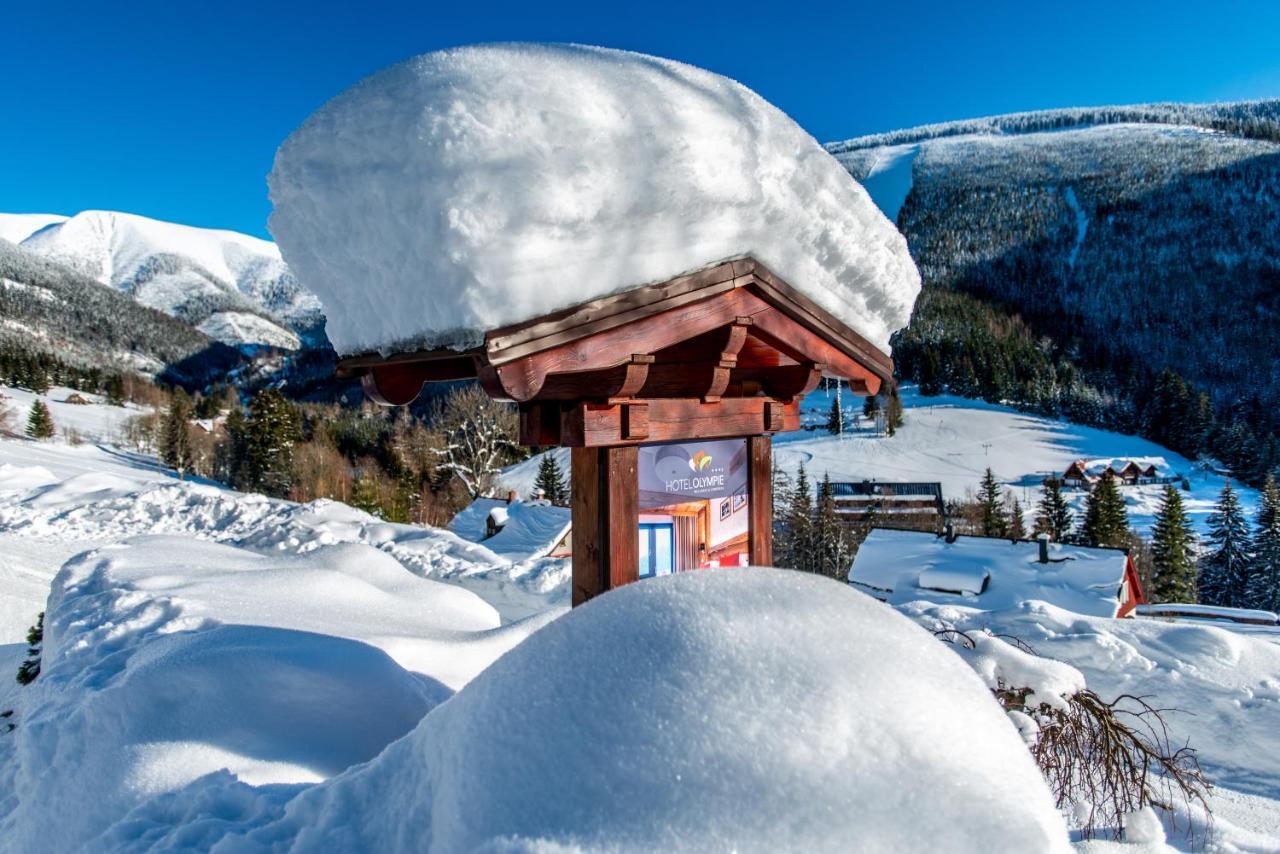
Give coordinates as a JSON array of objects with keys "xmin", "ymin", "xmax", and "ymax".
[{"xmin": 0, "ymin": 389, "xmax": 1280, "ymax": 851}]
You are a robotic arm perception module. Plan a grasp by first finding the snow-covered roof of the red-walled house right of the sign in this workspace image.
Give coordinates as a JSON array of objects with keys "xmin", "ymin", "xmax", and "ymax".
[{"xmin": 849, "ymin": 529, "xmax": 1128, "ymax": 617}]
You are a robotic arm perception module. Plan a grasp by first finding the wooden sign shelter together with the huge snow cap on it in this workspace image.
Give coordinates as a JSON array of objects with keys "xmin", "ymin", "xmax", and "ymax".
[{"xmin": 270, "ymin": 45, "xmax": 920, "ymax": 603}]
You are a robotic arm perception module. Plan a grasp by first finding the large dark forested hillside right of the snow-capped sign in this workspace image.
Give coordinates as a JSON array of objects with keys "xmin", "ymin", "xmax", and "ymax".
[{"xmin": 831, "ymin": 102, "xmax": 1280, "ymax": 483}]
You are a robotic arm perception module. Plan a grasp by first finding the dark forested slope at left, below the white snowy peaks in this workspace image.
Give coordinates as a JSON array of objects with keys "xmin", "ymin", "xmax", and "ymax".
[{"xmin": 0, "ymin": 239, "xmax": 244, "ymax": 385}]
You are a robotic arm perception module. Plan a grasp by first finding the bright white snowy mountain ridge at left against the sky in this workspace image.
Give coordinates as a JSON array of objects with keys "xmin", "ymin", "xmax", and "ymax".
[{"xmin": 0, "ymin": 210, "xmax": 323, "ymax": 350}]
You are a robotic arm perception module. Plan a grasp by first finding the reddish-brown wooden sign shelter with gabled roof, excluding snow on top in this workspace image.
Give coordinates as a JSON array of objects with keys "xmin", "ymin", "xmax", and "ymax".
[{"xmin": 338, "ymin": 257, "xmax": 893, "ymax": 604}]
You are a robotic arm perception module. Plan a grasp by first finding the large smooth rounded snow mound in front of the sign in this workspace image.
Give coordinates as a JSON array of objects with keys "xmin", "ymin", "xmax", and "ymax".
[{"xmin": 207, "ymin": 568, "xmax": 1068, "ymax": 851}]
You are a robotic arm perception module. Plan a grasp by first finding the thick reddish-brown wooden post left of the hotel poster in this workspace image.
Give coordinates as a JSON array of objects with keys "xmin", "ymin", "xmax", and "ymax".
[{"xmin": 570, "ymin": 446, "xmax": 640, "ymax": 607}]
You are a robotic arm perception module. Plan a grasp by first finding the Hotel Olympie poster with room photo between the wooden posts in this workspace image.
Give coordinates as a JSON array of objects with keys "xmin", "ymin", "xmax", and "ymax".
[{"xmin": 637, "ymin": 439, "xmax": 750, "ymax": 577}]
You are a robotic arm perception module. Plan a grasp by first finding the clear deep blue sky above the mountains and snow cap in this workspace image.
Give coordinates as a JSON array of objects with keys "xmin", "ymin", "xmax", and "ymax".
[{"xmin": 0, "ymin": 0, "xmax": 1280, "ymax": 237}]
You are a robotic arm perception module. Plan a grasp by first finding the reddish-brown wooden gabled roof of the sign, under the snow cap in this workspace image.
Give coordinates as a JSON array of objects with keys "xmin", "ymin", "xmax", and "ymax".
[{"xmin": 338, "ymin": 257, "xmax": 893, "ymax": 421}]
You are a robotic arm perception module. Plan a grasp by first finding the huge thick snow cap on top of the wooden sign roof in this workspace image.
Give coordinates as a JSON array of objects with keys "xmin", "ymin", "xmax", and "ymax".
[{"xmin": 269, "ymin": 44, "xmax": 920, "ymax": 355}]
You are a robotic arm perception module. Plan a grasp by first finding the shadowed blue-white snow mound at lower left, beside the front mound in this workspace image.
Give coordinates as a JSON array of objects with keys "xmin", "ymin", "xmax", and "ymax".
[{"xmin": 0, "ymin": 536, "xmax": 554, "ymax": 851}]
